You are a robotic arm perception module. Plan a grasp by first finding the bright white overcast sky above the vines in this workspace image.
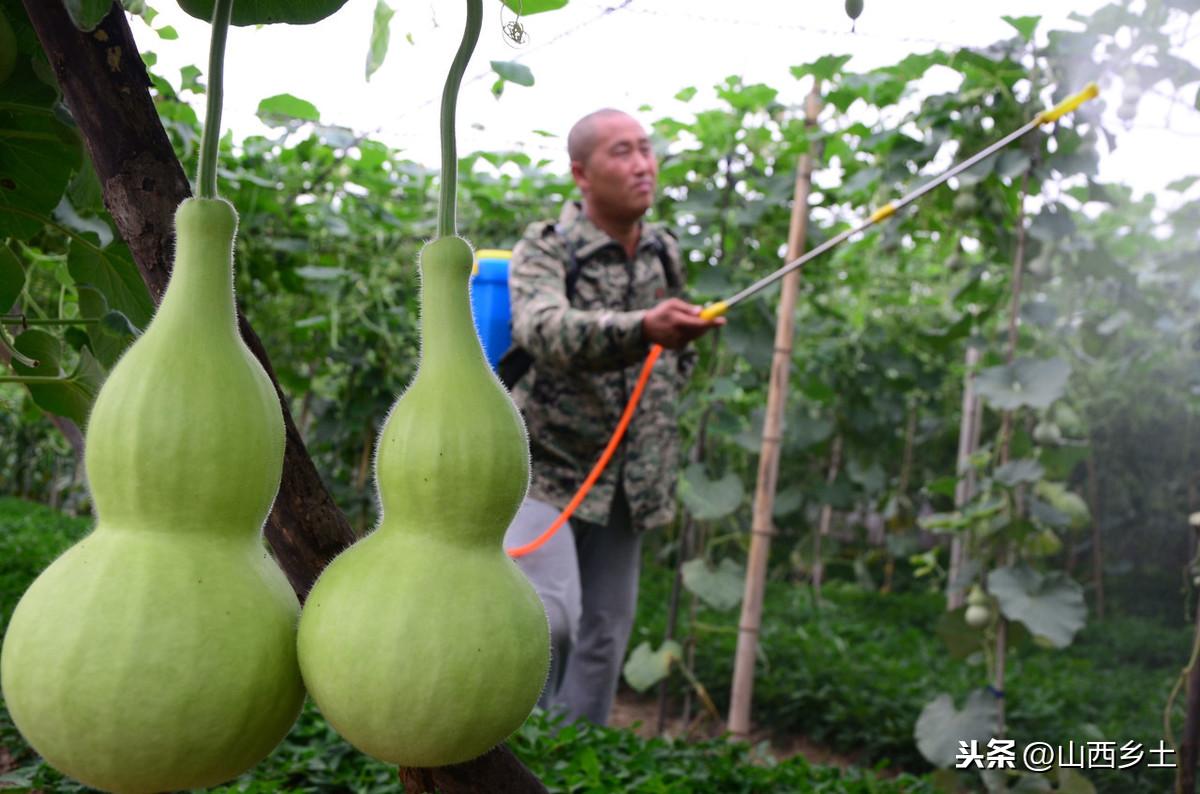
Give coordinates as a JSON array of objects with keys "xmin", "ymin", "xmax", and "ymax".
[{"xmin": 134, "ymin": 0, "xmax": 1200, "ymax": 199}]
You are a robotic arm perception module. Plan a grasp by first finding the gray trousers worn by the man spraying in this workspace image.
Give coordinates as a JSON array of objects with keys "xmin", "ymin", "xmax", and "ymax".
[{"xmin": 504, "ymin": 489, "xmax": 642, "ymax": 724}]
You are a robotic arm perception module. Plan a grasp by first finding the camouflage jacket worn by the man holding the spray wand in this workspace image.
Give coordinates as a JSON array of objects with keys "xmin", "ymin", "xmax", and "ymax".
[{"xmin": 509, "ymin": 201, "xmax": 695, "ymax": 530}]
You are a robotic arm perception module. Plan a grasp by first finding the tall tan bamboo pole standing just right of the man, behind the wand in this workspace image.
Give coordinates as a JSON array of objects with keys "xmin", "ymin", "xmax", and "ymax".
[{"xmin": 728, "ymin": 79, "xmax": 821, "ymax": 739}]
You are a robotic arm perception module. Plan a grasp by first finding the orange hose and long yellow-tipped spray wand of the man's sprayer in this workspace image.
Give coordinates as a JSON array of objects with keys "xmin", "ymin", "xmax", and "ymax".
[{"xmin": 508, "ymin": 83, "xmax": 1099, "ymax": 558}]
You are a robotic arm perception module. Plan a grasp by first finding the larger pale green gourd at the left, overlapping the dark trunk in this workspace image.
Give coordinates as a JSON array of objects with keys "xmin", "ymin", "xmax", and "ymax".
[{"xmin": 0, "ymin": 199, "xmax": 304, "ymax": 794}]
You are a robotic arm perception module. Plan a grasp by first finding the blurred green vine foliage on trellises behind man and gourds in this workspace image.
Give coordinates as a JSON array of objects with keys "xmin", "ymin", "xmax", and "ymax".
[{"xmin": 0, "ymin": 0, "xmax": 1200, "ymax": 790}]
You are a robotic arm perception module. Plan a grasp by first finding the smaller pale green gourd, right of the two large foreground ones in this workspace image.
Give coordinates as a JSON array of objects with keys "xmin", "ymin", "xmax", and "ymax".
[{"xmin": 299, "ymin": 237, "xmax": 550, "ymax": 766}]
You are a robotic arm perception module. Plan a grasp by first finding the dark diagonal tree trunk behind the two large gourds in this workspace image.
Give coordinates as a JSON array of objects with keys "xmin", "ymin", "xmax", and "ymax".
[{"xmin": 23, "ymin": 0, "xmax": 546, "ymax": 794}]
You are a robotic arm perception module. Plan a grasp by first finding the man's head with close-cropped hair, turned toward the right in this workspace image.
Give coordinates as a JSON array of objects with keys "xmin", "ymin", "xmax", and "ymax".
[{"xmin": 571, "ymin": 114, "xmax": 659, "ymax": 222}]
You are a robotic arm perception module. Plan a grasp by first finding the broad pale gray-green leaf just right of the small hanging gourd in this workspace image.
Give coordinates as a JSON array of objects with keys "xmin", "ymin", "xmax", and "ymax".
[{"xmin": 988, "ymin": 564, "xmax": 1087, "ymax": 648}]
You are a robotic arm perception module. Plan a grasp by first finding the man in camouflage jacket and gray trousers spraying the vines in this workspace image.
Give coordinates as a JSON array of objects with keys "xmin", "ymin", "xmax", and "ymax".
[{"xmin": 505, "ymin": 109, "xmax": 724, "ymax": 724}]
